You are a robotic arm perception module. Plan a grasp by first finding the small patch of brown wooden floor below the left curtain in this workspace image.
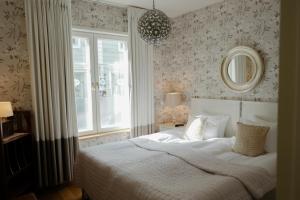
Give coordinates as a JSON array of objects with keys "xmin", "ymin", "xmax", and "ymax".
[{"xmin": 37, "ymin": 185, "xmax": 82, "ymax": 200}]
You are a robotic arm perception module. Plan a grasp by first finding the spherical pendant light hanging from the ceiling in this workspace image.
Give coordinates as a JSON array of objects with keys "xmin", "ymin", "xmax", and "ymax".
[{"xmin": 138, "ymin": 0, "xmax": 171, "ymax": 44}]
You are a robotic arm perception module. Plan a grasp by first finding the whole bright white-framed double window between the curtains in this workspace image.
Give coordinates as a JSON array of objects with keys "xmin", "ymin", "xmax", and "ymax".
[{"xmin": 72, "ymin": 31, "xmax": 130, "ymax": 134}]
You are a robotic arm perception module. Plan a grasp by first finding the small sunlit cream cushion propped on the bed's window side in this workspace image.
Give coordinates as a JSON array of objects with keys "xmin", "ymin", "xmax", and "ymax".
[{"xmin": 184, "ymin": 116, "xmax": 207, "ymax": 141}]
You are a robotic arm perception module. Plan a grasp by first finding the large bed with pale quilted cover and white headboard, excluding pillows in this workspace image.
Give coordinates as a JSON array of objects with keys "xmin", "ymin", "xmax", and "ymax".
[{"xmin": 75, "ymin": 99, "xmax": 277, "ymax": 200}]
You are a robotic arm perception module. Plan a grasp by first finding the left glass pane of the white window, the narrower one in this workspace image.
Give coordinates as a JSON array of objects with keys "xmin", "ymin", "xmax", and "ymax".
[{"xmin": 73, "ymin": 36, "xmax": 93, "ymax": 132}]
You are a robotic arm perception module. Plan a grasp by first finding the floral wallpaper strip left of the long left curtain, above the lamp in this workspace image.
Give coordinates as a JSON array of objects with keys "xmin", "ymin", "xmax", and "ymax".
[{"xmin": 0, "ymin": 0, "xmax": 31, "ymax": 110}]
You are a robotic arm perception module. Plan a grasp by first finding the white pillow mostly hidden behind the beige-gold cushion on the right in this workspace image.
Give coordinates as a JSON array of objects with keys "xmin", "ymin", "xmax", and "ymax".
[{"xmin": 241, "ymin": 116, "xmax": 277, "ymax": 152}]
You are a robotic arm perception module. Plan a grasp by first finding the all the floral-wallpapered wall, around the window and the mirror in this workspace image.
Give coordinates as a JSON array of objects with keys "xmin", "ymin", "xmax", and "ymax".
[{"xmin": 0, "ymin": 0, "xmax": 280, "ymax": 128}]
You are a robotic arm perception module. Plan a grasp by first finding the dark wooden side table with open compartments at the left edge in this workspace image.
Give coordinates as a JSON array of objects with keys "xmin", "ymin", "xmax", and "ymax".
[{"xmin": 0, "ymin": 133, "xmax": 34, "ymax": 199}]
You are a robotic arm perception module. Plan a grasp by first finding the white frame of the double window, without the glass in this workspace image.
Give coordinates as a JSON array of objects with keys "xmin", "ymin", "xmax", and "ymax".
[{"xmin": 72, "ymin": 28, "xmax": 130, "ymax": 136}]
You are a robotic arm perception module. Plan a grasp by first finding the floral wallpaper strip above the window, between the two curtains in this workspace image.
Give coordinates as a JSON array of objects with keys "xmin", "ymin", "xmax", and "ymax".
[{"xmin": 72, "ymin": 0, "xmax": 128, "ymax": 32}]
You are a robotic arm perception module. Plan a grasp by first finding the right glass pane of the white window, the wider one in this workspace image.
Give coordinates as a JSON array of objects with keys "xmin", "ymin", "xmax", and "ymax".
[{"xmin": 97, "ymin": 39, "xmax": 129, "ymax": 129}]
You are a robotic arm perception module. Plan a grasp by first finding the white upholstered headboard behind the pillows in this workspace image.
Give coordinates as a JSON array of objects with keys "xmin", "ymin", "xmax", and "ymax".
[{"xmin": 191, "ymin": 98, "xmax": 277, "ymax": 137}]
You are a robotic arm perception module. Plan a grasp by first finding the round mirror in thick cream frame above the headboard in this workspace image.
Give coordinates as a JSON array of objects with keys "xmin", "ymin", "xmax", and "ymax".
[{"xmin": 221, "ymin": 46, "xmax": 263, "ymax": 93}]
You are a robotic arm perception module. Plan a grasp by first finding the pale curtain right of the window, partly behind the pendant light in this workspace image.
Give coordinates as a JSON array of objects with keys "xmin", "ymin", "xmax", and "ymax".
[{"xmin": 128, "ymin": 7, "xmax": 154, "ymax": 137}]
